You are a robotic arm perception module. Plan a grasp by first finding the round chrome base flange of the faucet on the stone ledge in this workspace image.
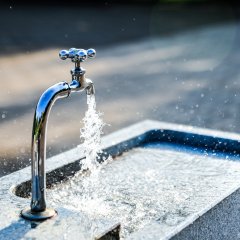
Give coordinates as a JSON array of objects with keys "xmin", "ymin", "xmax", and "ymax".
[{"xmin": 21, "ymin": 208, "xmax": 57, "ymax": 221}]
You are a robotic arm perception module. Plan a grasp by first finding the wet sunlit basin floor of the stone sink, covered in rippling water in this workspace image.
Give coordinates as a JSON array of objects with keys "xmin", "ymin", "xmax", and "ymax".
[{"xmin": 48, "ymin": 143, "xmax": 240, "ymax": 239}]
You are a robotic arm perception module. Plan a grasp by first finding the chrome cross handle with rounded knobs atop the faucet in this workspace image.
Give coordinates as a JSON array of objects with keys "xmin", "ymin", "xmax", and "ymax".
[{"xmin": 59, "ymin": 48, "xmax": 96, "ymax": 63}]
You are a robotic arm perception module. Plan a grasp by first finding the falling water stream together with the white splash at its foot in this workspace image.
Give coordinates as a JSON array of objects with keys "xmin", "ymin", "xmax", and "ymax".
[{"xmin": 49, "ymin": 94, "xmax": 111, "ymax": 239}]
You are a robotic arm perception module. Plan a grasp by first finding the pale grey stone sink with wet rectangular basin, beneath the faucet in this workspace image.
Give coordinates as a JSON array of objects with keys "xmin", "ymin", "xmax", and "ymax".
[{"xmin": 0, "ymin": 120, "xmax": 240, "ymax": 240}]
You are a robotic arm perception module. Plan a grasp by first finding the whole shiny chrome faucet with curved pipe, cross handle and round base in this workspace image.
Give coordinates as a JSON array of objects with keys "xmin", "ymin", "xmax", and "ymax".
[{"xmin": 21, "ymin": 48, "xmax": 96, "ymax": 221}]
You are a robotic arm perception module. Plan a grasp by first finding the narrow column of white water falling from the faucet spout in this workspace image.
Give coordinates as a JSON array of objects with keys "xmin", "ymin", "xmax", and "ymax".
[{"xmin": 80, "ymin": 94, "xmax": 106, "ymax": 173}]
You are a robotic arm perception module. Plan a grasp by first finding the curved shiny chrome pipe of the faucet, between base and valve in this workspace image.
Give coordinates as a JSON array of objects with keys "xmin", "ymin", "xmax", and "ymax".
[{"xmin": 31, "ymin": 82, "xmax": 71, "ymax": 212}]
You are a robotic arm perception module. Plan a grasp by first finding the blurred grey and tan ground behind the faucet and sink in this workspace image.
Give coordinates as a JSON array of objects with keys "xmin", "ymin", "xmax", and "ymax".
[{"xmin": 0, "ymin": 0, "xmax": 240, "ymax": 176}]
